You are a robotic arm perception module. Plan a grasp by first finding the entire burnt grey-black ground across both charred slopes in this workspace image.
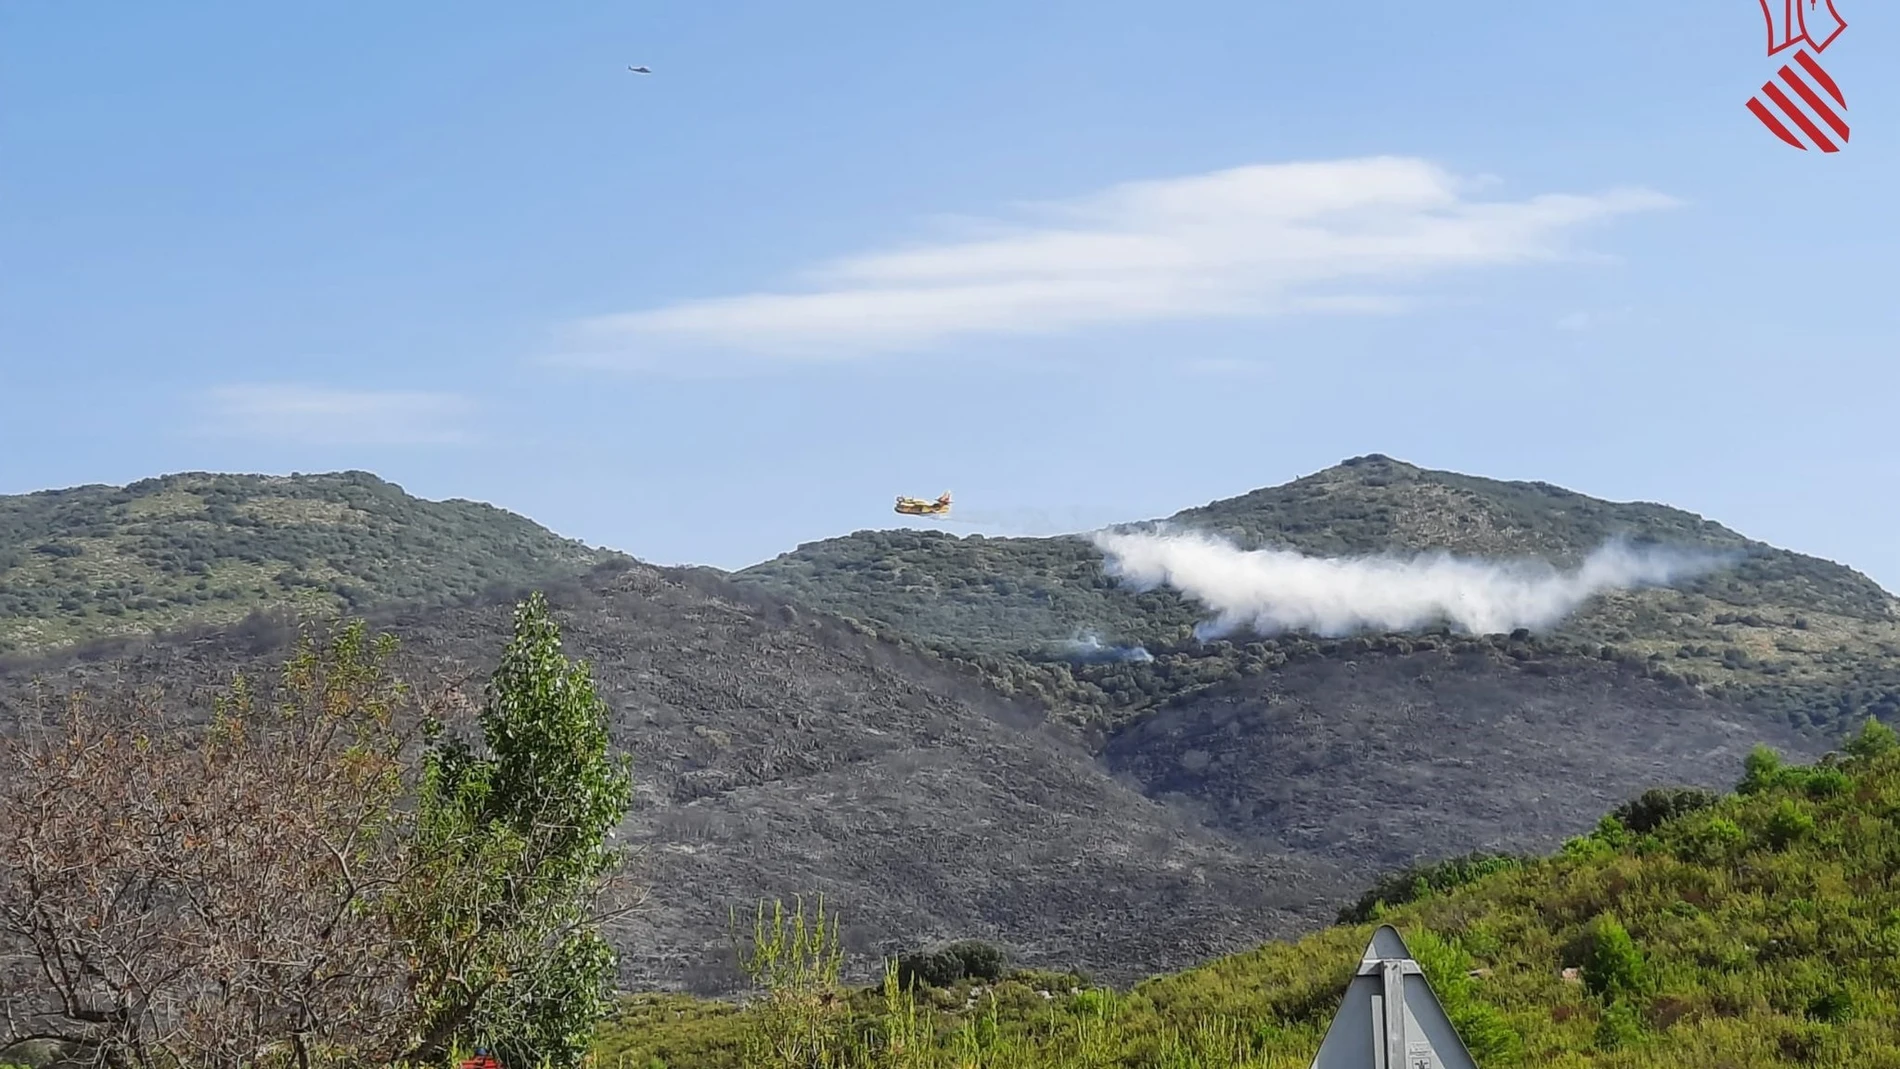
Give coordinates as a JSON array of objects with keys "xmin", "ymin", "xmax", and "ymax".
[{"xmin": 0, "ymin": 562, "xmax": 1803, "ymax": 991}]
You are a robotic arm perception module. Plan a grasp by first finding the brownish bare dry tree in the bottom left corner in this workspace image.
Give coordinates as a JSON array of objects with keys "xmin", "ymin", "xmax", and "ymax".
[{"xmin": 0, "ymin": 618, "xmax": 640, "ymax": 1069}]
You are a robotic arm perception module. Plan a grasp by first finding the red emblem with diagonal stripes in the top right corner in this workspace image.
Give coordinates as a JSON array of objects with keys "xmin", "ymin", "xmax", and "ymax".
[{"xmin": 1748, "ymin": 0, "xmax": 1847, "ymax": 152}]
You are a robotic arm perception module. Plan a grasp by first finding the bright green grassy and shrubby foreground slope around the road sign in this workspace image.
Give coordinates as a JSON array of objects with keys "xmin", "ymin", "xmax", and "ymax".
[{"xmin": 595, "ymin": 722, "xmax": 1900, "ymax": 1069}]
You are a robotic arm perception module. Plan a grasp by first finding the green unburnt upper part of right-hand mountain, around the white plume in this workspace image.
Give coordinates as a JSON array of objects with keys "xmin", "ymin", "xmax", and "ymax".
[{"xmin": 737, "ymin": 456, "xmax": 1900, "ymax": 731}]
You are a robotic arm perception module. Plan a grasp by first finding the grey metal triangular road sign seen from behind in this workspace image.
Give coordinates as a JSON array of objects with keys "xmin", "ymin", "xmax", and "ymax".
[{"xmin": 1313, "ymin": 925, "xmax": 1478, "ymax": 1069}]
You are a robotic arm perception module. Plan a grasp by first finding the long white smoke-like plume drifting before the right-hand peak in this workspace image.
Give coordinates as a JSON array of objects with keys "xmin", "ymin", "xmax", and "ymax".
[{"xmin": 1091, "ymin": 532, "xmax": 1725, "ymax": 638}]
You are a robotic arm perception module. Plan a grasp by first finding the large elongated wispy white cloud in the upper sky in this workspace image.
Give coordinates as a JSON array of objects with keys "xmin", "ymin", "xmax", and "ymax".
[{"xmin": 555, "ymin": 158, "xmax": 1676, "ymax": 366}]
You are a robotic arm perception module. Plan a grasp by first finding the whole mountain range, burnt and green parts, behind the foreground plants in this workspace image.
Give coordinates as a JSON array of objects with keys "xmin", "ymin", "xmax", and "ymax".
[{"xmin": 0, "ymin": 458, "xmax": 1877, "ymax": 987}]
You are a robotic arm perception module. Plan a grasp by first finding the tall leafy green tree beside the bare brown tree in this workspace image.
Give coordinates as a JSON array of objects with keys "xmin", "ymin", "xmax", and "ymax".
[{"xmin": 403, "ymin": 594, "xmax": 633, "ymax": 1067}]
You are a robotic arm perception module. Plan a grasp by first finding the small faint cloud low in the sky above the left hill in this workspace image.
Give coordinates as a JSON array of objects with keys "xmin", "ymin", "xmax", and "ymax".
[{"xmin": 201, "ymin": 384, "xmax": 473, "ymax": 444}]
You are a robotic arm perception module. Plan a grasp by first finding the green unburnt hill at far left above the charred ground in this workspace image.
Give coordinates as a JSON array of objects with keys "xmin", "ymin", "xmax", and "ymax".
[{"xmin": 0, "ymin": 471, "xmax": 606, "ymax": 653}]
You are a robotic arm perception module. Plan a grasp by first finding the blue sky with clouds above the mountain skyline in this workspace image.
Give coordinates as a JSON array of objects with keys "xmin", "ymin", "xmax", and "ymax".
[{"xmin": 0, "ymin": 0, "xmax": 1900, "ymax": 591}]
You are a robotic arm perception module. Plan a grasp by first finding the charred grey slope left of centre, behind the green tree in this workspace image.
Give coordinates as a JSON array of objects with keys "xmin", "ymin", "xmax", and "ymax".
[{"xmin": 0, "ymin": 562, "xmax": 1351, "ymax": 989}]
